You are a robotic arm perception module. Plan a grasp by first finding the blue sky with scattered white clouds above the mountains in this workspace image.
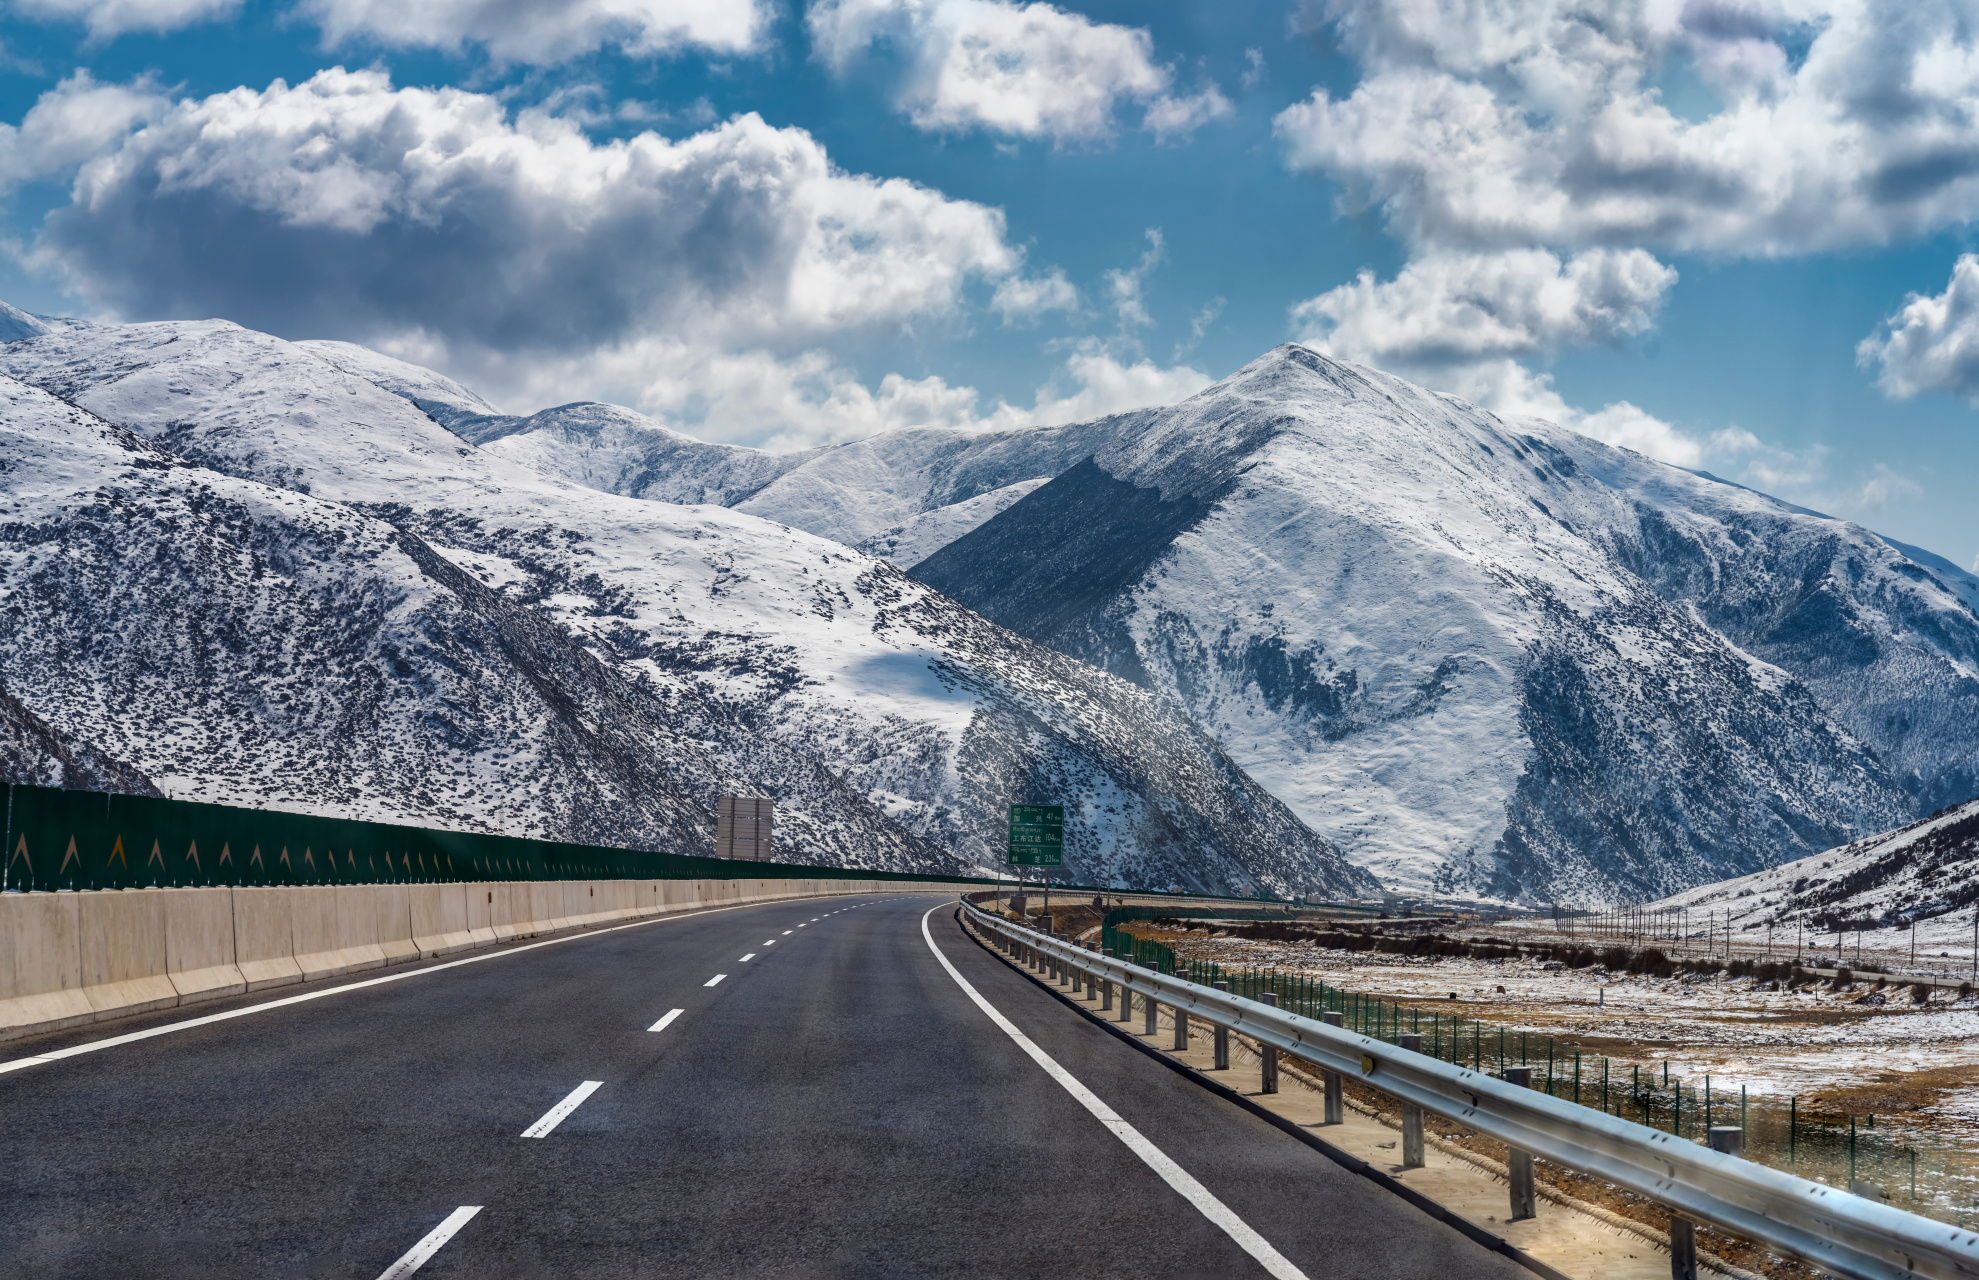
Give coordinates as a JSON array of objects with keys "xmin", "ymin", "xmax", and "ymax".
[{"xmin": 0, "ymin": 0, "xmax": 1979, "ymax": 566}]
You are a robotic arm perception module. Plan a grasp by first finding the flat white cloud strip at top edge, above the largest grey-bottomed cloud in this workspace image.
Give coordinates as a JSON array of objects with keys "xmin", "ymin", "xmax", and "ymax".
[{"xmin": 296, "ymin": 0, "xmax": 770, "ymax": 65}]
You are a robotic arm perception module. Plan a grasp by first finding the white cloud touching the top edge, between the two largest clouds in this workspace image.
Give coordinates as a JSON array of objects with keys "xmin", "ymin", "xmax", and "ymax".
[{"xmin": 807, "ymin": 0, "xmax": 1231, "ymax": 144}]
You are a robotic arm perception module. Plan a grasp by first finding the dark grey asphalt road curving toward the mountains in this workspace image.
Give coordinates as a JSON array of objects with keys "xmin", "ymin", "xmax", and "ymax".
[{"xmin": 0, "ymin": 896, "xmax": 1530, "ymax": 1280}]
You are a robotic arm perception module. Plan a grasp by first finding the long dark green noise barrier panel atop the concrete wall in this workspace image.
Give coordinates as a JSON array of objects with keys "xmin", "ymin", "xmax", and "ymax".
[{"xmin": 0, "ymin": 783, "xmax": 982, "ymax": 890}]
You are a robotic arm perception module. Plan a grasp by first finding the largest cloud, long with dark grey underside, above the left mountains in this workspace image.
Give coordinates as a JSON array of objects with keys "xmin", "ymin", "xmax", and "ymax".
[{"xmin": 12, "ymin": 69, "xmax": 1084, "ymax": 364}]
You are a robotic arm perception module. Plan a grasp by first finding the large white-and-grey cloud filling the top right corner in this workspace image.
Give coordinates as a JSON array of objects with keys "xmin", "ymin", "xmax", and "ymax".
[{"xmin": 1276, "ymin": 0, "xmax": 1979, "ymax": 255}]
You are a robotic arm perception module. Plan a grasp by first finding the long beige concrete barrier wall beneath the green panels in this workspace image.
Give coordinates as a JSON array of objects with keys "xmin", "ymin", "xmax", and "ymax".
[{"xmin": 0, "ymin": 878, "xmax": 956, "ymax": 1041}]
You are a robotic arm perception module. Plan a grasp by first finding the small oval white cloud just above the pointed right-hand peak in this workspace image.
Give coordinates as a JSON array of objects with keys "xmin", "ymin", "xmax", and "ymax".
[{"xmin": 1292, "ymin": 249, "xmax": 1676, "ymax": 368}]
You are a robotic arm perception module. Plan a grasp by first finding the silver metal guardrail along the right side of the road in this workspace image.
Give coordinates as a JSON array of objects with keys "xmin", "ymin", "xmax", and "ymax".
[{"xmin": 962, "ymin": 902, "xmax": 1979, "ymax": 1280}]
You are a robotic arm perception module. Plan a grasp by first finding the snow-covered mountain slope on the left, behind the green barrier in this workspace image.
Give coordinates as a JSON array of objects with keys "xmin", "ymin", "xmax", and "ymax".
[{"xmin": 0, "ymin": 320, "xmax": 1371, "ymax": 892}]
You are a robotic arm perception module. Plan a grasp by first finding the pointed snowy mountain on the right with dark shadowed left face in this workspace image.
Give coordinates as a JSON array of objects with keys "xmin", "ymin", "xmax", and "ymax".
[{"xmin": 914, "ymin": 344, "xmax": 1979, "ymax": 902}]
